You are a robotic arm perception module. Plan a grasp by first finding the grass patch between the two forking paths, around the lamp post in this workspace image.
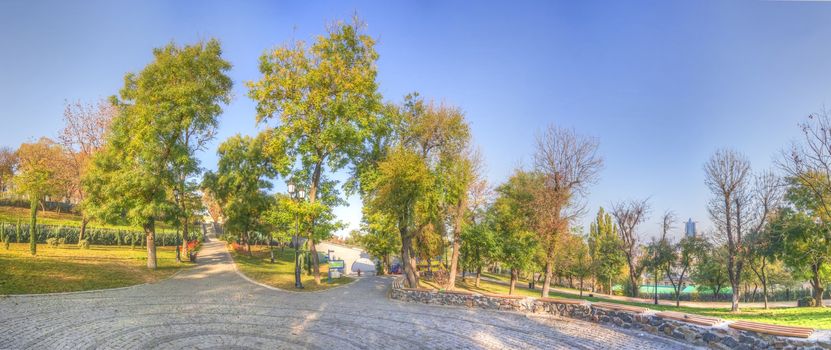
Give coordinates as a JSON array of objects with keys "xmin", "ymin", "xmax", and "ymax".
[{"xmin": 228, "ymin": 246, "xmax": 352, "ymax": 292}]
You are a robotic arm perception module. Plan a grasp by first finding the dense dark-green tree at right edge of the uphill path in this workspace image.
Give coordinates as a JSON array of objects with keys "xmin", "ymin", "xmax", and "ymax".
[{"xmin": 203, "ymin": 135, "xmax": 276, "ymax": 255}]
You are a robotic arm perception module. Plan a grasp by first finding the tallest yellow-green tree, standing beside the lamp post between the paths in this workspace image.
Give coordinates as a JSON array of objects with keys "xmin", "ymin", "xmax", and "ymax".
[{"xmin": 248, "ymin": 19, "xmax": 380, "ymax": 283}]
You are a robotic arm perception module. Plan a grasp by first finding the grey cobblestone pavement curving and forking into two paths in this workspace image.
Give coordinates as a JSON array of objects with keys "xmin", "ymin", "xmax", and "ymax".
[{"xmin": 0, "ymin": 237, "xmax": 704, "ymax": 350}]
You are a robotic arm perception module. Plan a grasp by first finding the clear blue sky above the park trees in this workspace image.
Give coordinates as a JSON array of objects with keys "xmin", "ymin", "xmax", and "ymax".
[{"xmin": 0, "ymin": 0, "xmax": 831, "ymax": 239}]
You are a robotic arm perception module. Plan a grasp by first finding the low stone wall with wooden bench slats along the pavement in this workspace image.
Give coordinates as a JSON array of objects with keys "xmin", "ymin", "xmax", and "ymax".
[{"xmin": 390, "ymin": 277, "xmax": 831, "ymax": 350}]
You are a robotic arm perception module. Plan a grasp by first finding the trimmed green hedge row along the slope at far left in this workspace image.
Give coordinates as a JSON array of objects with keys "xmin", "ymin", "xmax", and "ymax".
[{"xmin": 0, "ymin": 222, "xmax": 202, "ymax": 246}]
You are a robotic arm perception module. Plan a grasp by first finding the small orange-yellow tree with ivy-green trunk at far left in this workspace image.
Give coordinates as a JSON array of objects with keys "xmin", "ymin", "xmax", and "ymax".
[{"xmin": 14, "ymin": 138, "xmax": 66, "ymax": 255}]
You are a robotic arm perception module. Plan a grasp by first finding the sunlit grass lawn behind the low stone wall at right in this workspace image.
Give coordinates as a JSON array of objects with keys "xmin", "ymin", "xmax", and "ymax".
[{"xmin": 425, "ymin": 274, "xmax": 831, "ymax": 329}]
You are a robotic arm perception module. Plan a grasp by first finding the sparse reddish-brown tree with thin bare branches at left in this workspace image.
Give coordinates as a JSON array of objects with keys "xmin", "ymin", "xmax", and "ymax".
[{"xmin": 58, "ymin": 100, "xmax": 117, "ymax": 242}]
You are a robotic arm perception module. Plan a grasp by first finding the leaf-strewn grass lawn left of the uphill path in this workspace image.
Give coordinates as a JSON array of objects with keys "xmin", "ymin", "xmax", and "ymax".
[{"xmin": 0, "ymin": 243, "xmax": 192, "ymax": 294}]
